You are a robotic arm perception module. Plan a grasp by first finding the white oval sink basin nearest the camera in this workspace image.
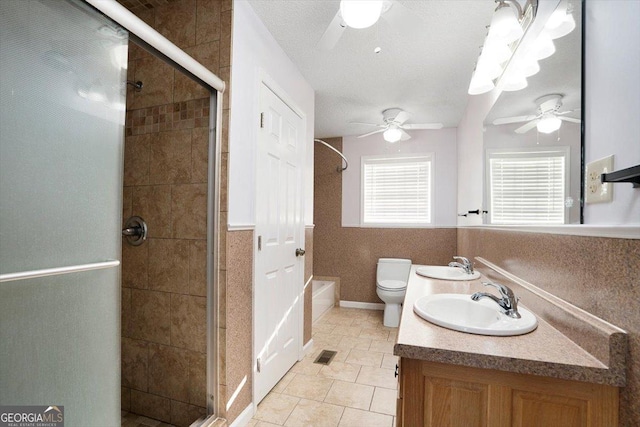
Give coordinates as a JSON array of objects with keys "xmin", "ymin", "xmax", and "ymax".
[{"xmin": 413, "ymin": 294, "xmax": 538, "ymax": 336}]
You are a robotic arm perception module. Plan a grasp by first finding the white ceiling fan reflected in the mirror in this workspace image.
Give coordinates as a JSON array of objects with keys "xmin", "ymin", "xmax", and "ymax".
[{"xmin": 493, "ymin": 93, "xmax": 581, "ymax": 133}]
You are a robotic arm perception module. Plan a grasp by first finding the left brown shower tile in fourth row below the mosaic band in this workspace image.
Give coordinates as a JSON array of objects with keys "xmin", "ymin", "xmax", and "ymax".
[{"xmin": 131, "ymin": 289, "xmax": 171, "ymax": 344}]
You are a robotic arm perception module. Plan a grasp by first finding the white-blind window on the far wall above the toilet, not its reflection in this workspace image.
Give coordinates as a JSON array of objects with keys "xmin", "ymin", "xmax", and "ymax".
[{"xmin": 361, "ymin": 154, "xmax": 433, "ymax": 227}]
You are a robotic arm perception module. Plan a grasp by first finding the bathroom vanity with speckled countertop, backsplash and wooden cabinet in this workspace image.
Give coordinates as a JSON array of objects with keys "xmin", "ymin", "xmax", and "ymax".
[{"xmin": 394, "ymin": 259, "xmax": 627, "ymax": 427}]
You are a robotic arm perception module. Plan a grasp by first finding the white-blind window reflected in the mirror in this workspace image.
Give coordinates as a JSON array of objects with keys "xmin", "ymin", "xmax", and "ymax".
[{"xmin": 486, "ymin": 147, "xmax": 569, "ymax": 225}]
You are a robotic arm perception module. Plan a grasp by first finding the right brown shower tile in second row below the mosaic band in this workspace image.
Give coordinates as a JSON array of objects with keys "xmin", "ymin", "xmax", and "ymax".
[{"xmin": 171, "ymin": 184, "xmax": 207, "ymax": 239}]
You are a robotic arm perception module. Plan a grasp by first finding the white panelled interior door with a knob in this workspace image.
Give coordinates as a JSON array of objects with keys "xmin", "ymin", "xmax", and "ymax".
[{"xmin": 254, "ymin": 83, "xmax": 304, "ymax": 403}]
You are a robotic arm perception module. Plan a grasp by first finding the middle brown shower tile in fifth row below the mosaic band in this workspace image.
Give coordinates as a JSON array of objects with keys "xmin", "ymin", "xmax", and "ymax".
[{"xmin": 149, "ymin": 344, "xmax": 189, "ymax": 402}]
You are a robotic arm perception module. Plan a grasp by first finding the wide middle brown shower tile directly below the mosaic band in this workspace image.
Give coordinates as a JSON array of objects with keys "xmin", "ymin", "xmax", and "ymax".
[{"xmin": 149, "ymin": 130, "xmax": 191, "ymax": 184}]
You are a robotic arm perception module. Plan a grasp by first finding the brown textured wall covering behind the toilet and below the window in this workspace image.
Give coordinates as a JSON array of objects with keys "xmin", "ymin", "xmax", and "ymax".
[{"xmin": 313, "ymin": 138, "xmax": 456, "ymax": 303}]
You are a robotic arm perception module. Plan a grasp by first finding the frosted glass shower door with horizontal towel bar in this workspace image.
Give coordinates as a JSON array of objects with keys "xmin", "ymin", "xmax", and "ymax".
[{"xmin": 0, "ymin": 0, "xmax": 128, "ymax": 426}]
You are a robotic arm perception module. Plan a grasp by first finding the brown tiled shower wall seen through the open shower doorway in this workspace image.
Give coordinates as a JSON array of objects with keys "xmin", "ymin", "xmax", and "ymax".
[{"xmin": 122, "ymin": 0, "xmax": 231, "ymax": 425}]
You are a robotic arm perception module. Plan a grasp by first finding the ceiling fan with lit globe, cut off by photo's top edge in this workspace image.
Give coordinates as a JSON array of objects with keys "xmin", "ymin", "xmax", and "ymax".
[{"xmin": 316, "ymin": 0, "xmax": 416, "ymax": 51}]
